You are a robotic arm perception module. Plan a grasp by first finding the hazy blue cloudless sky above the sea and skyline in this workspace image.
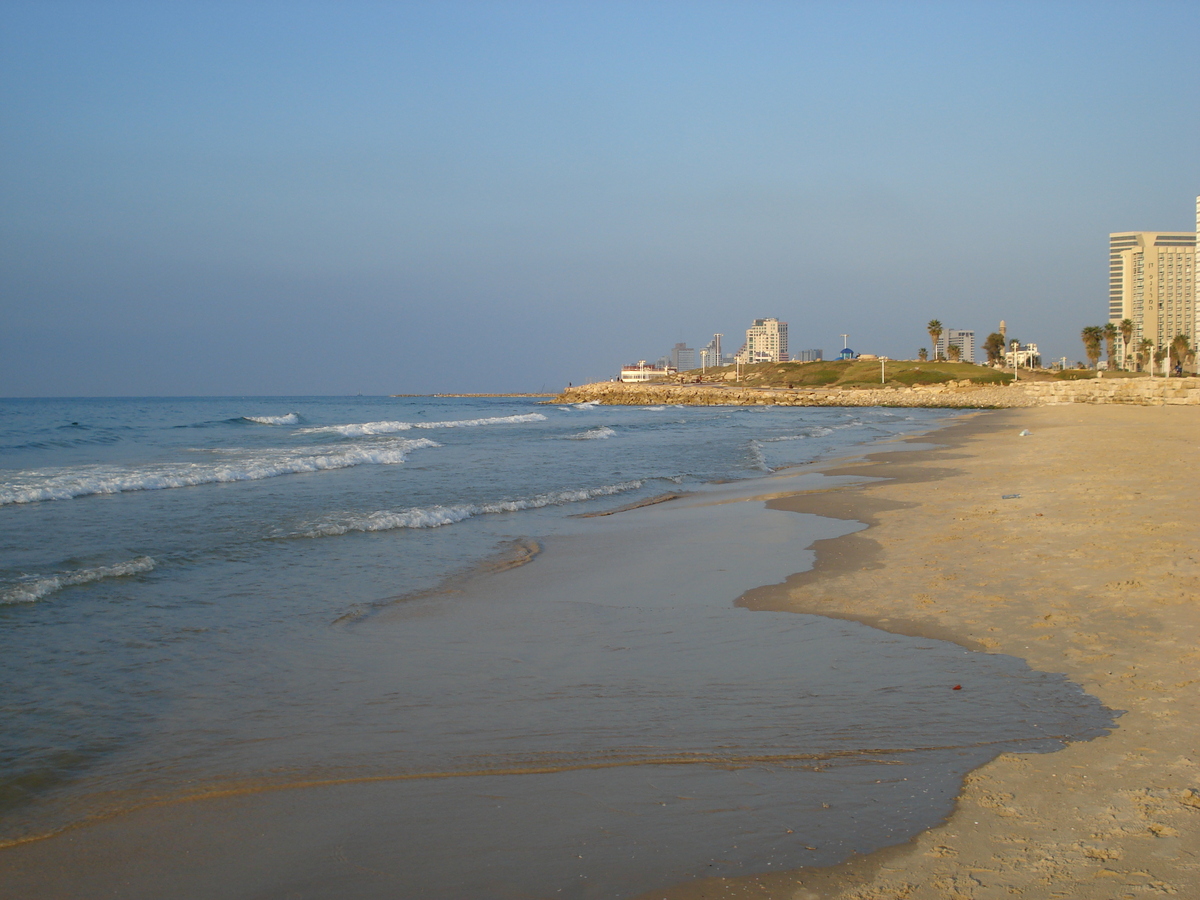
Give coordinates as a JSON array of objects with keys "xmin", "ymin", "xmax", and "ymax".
[{"xmin": 0, "ymin": 0, "xmax": 1200, "ymax": 397}]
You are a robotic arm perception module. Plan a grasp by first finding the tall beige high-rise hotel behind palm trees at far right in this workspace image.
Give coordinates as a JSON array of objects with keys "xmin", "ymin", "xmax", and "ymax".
[{"xmin": 1109, "ymin": 230, "xmax": 1200, "ymax": 367}]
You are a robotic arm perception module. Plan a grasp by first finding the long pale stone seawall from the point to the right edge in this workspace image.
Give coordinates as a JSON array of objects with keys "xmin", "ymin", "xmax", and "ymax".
[{"xmin": 551, "ymin": 378, "xmax": 1200, "ymax": 409}]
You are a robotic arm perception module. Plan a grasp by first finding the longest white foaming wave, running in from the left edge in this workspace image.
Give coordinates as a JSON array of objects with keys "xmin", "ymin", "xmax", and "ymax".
[{"xmin": 0, "ymin": 438, "xmax": 440, "ymax": 506}]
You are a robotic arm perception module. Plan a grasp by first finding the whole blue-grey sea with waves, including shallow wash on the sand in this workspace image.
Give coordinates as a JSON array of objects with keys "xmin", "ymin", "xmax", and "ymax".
[{"xmin": 0, "ymin": 397, "xmax": 1112, "ymax": 898}]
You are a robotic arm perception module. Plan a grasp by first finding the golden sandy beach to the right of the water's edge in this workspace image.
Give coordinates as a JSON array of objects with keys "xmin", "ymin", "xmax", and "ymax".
[{"xmin": 646, "ymin": 406, "xmax": 1200, "ymax": 900}]
